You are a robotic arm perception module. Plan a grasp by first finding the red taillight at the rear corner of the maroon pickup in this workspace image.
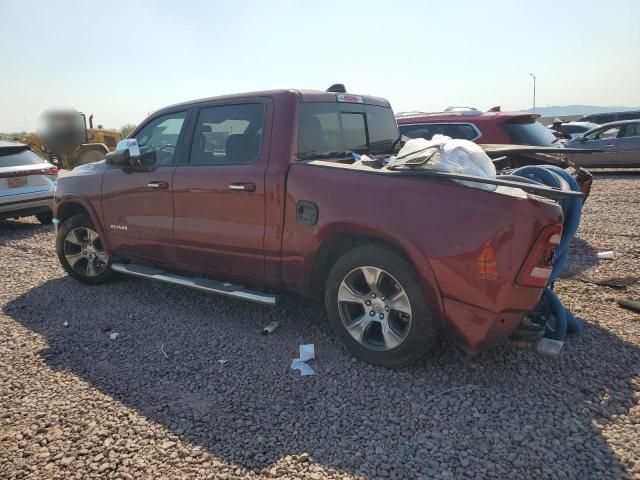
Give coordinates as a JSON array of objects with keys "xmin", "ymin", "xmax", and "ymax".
[{"xmin": 516, "ymin": 225, "xmax": 562, "ymax": 288}]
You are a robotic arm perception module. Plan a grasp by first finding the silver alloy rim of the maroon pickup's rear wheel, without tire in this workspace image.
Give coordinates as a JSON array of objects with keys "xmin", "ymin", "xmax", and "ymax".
[{"xmin": 338, "ymin": 266, "xmax": 411, "ymax": 350}]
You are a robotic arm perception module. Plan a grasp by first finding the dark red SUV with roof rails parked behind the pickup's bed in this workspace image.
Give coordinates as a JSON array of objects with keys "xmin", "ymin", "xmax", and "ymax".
[{"xmin": 396, "ymin": 107, "xmax": 558, "ymax": 146}]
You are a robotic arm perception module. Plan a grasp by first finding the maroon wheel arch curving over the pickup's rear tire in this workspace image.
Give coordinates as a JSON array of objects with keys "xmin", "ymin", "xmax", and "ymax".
[{"xmin": 309, "ymin": 225, "xmax": 444, "ymax": 318}]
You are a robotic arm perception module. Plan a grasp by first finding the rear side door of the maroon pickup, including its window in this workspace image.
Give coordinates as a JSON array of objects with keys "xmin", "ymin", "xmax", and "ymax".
[{"xmin": 173, "ymin": 100, "xmax": 273, "ymax": 278}]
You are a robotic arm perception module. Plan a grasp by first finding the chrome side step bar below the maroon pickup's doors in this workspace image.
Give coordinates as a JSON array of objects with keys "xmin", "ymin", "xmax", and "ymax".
[{"xmin": 111, "ymin": 263, "xmax": 276, "ymax": 305}]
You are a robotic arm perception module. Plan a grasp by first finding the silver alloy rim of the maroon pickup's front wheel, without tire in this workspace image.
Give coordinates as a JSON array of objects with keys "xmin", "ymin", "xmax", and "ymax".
[{"xmin": 64, "ymin": 227, "xmax": 109, "ymax": 277}]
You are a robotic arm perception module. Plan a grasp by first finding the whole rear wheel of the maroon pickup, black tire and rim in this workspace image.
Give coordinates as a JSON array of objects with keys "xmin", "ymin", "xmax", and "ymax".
[{"xmin": 325, "ymin": 246, "xmax": 437, "ymax": 367}]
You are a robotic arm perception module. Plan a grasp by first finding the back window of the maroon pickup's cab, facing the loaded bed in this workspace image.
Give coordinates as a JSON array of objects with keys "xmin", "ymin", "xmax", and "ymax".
[{"xmin": 298, "ymin": 102, "xmax": 398, "ymax": 160}]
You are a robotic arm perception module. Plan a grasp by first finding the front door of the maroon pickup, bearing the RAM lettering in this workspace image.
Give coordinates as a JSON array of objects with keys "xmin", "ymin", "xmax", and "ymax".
[{"xmin": 102, "ymin": 111, "xmax": 188, "ymax": 263}]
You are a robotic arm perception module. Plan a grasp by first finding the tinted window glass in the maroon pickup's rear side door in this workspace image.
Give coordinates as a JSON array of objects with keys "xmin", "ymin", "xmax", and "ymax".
[{"xmin": 189, "ymin": 103, "xmax": 264, "ymax": 165}]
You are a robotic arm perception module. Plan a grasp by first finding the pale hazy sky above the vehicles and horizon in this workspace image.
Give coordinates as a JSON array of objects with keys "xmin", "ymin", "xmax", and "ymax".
[{"xmin": 0, "ymin": 0, "xmax": 640, "ymax": 131}]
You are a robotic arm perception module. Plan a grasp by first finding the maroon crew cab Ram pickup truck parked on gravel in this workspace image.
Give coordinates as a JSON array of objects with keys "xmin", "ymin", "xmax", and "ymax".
[{"xmin": 54, "ymin": 90, "xmax": 563, "ymax": 367}]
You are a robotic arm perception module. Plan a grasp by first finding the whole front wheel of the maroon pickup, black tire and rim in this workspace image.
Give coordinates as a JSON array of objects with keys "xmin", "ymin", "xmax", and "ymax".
[{"xmin": 56, "ymin": 214, "xmax": 115, "ymax": 285}]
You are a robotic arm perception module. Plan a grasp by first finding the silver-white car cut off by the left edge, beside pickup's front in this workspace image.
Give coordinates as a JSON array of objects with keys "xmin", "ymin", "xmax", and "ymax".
[{"xmin": 0, "ymin": 141, "xmax": 58, "ymax": 225}]
